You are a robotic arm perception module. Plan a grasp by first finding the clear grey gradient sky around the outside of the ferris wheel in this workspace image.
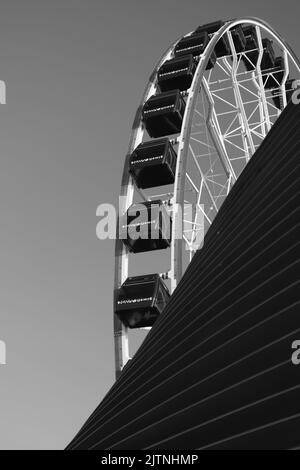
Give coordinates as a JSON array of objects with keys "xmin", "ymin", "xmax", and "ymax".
[{"xmin": 0, "ymin": 0, "xmax": 300, "ymax": 449}]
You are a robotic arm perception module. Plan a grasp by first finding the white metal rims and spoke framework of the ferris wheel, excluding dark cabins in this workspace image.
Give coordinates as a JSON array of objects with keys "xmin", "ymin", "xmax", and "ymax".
[{"xmin": 114, "ymin": 18, "xmax": 300, "ymax": 376}]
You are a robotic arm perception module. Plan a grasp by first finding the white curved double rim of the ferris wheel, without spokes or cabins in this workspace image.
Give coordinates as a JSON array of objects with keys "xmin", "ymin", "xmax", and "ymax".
[{"xmin": 114, "ymin": 17, "xmax": 300, "ymax": 378}]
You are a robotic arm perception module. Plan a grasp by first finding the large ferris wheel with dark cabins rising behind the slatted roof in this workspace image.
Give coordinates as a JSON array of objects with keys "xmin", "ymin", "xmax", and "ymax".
[{"xmin": 114, "ymin": 18, "xmax": 300, "ymax": 377}]
